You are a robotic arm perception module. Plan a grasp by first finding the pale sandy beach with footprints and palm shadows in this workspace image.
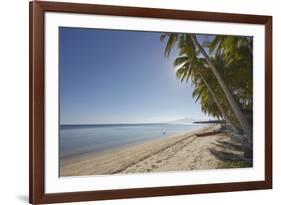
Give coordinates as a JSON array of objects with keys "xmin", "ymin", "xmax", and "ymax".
[{"xmin": 60, "ymin": 125, "xmax": 248, "ymax": 176}]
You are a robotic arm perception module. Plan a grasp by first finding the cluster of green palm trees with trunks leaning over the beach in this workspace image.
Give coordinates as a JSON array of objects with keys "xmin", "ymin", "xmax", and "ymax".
[{"xmin": 161, "ymin": 33, "xmax": 253, "ymax": 158}]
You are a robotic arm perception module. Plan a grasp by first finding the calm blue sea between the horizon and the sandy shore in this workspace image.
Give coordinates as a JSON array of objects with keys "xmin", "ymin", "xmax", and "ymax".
[{"xmin": 59, "ymin": 124, "xmax": 206, "ymax": 158}]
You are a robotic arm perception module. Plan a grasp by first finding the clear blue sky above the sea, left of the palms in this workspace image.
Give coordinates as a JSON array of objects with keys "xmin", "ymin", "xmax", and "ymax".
[{"xmin": 59, "ymin": 27, "xmax": 208, "ymax": 124}]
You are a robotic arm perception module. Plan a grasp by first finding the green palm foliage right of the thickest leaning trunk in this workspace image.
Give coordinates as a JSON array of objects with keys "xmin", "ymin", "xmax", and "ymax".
[{"xmin": 208, "ymin": 36, "xmax": 253, "ymax": 123}]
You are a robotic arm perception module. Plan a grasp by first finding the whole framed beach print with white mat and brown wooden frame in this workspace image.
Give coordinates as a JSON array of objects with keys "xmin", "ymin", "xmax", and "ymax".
[{"xmin": 30, "ymin": 1, "xmax": 272, "ymax": 204}]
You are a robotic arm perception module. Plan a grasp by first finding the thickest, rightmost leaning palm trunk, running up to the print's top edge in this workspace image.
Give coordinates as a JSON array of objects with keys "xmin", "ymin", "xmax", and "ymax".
[{"xmin": 191, "ymin": 35, "xmax": 252, "ymax": 147}]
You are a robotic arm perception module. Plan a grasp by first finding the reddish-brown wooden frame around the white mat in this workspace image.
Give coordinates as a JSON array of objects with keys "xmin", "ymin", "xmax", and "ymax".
[{"xmin": 29, "ymin": 1, "xmax": 272, "ymax": 204}]
